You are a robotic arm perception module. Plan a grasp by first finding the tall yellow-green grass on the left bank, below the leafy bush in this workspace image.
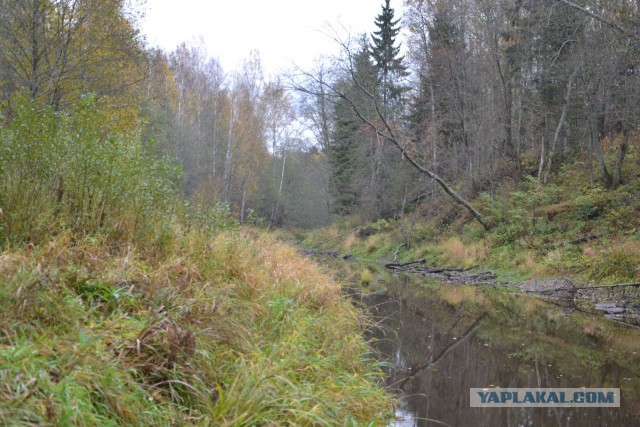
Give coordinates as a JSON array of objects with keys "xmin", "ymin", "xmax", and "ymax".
[{"xmin": 0, "ymin": 230, "xmax": 390, "ymax": 426}]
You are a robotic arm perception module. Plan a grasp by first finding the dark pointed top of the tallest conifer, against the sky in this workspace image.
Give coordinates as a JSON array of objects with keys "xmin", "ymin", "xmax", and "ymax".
[{"xmin": 370, "ymin": 0, "xmax": 409, "ymax": 106}]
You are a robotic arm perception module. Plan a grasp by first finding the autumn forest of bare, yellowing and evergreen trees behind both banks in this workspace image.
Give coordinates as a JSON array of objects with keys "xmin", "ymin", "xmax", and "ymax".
[{"xmin": 2, "ymin": 1, "xmax": 640, "ymax": 234}]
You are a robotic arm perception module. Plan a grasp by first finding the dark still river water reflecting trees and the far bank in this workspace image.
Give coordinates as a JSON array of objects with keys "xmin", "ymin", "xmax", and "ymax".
[{"xmin": 352, "ymin": 267, "xmax": 640, "ymax": 427}]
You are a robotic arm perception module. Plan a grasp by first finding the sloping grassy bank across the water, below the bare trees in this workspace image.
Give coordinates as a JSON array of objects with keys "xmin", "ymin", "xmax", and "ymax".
[{"xmin": 297, "ymin": 152, "xmax": 640, "ymax": 284}]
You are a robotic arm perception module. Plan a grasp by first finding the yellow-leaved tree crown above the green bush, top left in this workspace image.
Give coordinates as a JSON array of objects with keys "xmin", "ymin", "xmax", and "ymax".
[{"xmin": 0, "ymin": 0, "xmax": 144, "ymax": 113}]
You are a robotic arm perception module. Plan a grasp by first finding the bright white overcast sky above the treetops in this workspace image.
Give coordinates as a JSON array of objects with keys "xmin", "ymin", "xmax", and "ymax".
[{"xmin": 141, "ymin": 0, "xmax": 402, "ymax": 74}]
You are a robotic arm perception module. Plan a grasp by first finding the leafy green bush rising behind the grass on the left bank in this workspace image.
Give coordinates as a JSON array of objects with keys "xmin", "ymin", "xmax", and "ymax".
[{"xmin": 0, "ymin": 96, "xmax": 178, "ymax": 246}]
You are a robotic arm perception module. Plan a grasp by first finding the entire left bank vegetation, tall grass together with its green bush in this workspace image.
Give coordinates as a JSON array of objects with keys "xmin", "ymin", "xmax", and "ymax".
[{"xmin": 0, "ymin": 97, "xmax": 390, "ymax": 426}]
